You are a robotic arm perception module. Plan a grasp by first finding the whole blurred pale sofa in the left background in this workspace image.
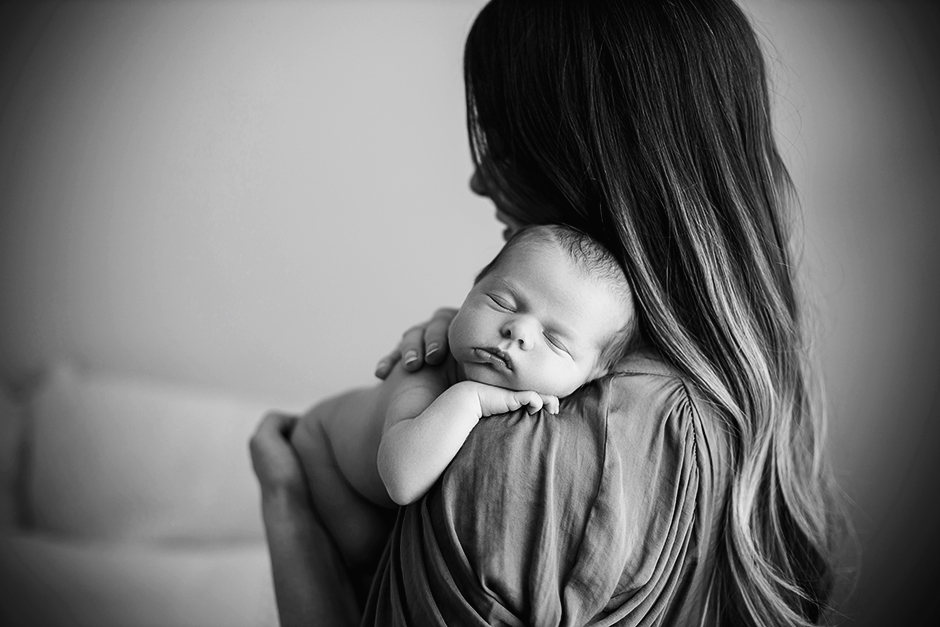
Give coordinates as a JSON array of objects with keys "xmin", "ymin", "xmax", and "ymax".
[{"xmin": 0, "ymin": 360, "xmax": 286, "ymax": 627}]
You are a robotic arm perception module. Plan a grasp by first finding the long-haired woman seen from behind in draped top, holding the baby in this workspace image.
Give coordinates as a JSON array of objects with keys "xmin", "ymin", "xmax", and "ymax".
[{"xmin": 252, "ymin": 0, "xmax": 839, "ymax": 625}]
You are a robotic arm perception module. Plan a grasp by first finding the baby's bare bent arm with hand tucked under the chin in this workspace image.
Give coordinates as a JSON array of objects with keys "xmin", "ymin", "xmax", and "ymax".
[{"xmin": 377, "ymin": 377, "xmax": 558, "ymax": 505}]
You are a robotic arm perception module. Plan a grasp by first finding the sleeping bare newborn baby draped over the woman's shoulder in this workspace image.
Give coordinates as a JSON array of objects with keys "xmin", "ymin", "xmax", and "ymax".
[{"xmin": 291, "ymin": 226, "xmax": 635, "ymax": 580}]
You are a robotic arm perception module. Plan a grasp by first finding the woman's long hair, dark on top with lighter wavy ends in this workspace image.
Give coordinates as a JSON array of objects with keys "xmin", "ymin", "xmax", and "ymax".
[{"xmin": 464, "ymin": 0, "xmax": 841, "ymax": 626}]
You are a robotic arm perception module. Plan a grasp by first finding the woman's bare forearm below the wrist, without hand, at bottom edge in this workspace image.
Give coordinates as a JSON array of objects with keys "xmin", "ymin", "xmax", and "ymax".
[{"xmin": 262, "ymin": 491, "xmax": 360, "ymax": 627}]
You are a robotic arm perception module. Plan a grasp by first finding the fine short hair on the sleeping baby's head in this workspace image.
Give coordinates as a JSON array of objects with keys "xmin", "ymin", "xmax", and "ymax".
[{"xmin": 473, "ymin": 224, "xmax": 637, "ymax": 368}]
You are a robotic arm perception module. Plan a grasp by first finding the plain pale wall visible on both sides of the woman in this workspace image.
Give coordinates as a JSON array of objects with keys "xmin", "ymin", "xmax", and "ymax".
[{"xmin": 0, "ymin": 0, "xmax": 940, "ymax": 625}]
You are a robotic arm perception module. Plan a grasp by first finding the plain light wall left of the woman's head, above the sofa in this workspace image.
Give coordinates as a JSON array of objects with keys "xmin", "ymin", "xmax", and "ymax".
[{"xmin": 0, "ymin": 2, "xmax": 500, "ymax": 398}]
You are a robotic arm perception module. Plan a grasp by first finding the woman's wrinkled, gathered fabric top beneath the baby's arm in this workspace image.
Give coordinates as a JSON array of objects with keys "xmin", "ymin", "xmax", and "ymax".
[{"xmin": 363, "ymin": 356, "xmax": 727, "ymax": 627}]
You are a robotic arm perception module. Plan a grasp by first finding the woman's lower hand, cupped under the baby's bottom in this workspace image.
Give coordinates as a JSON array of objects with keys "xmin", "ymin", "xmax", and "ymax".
[{"xmin": 249, "ymin": 411, "xmax": 307, "ymax": 499}]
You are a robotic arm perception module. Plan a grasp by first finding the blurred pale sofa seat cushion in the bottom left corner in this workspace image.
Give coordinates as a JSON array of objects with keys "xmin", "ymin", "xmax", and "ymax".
[{"xmin": 0, "ymin": 535, "xmax": 278, "ymax": 627}]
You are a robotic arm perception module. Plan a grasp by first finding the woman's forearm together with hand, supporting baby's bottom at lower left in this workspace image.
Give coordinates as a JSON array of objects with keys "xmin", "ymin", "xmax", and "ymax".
[{"xmin": 250, "ymin": 412, "xmax": 360, "ymax": 627}]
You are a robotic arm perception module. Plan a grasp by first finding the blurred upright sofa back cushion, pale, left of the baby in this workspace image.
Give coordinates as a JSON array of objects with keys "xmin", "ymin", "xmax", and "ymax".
[{"xmin": 26, "ymin": 363, "xmax": 298, "ymax": 541}]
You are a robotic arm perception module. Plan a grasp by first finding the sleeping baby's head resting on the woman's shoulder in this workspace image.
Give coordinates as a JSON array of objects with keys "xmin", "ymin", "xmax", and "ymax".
[{"xmin": 449, "ymin": 225, "xmax": 636, "ymax": 397}]
